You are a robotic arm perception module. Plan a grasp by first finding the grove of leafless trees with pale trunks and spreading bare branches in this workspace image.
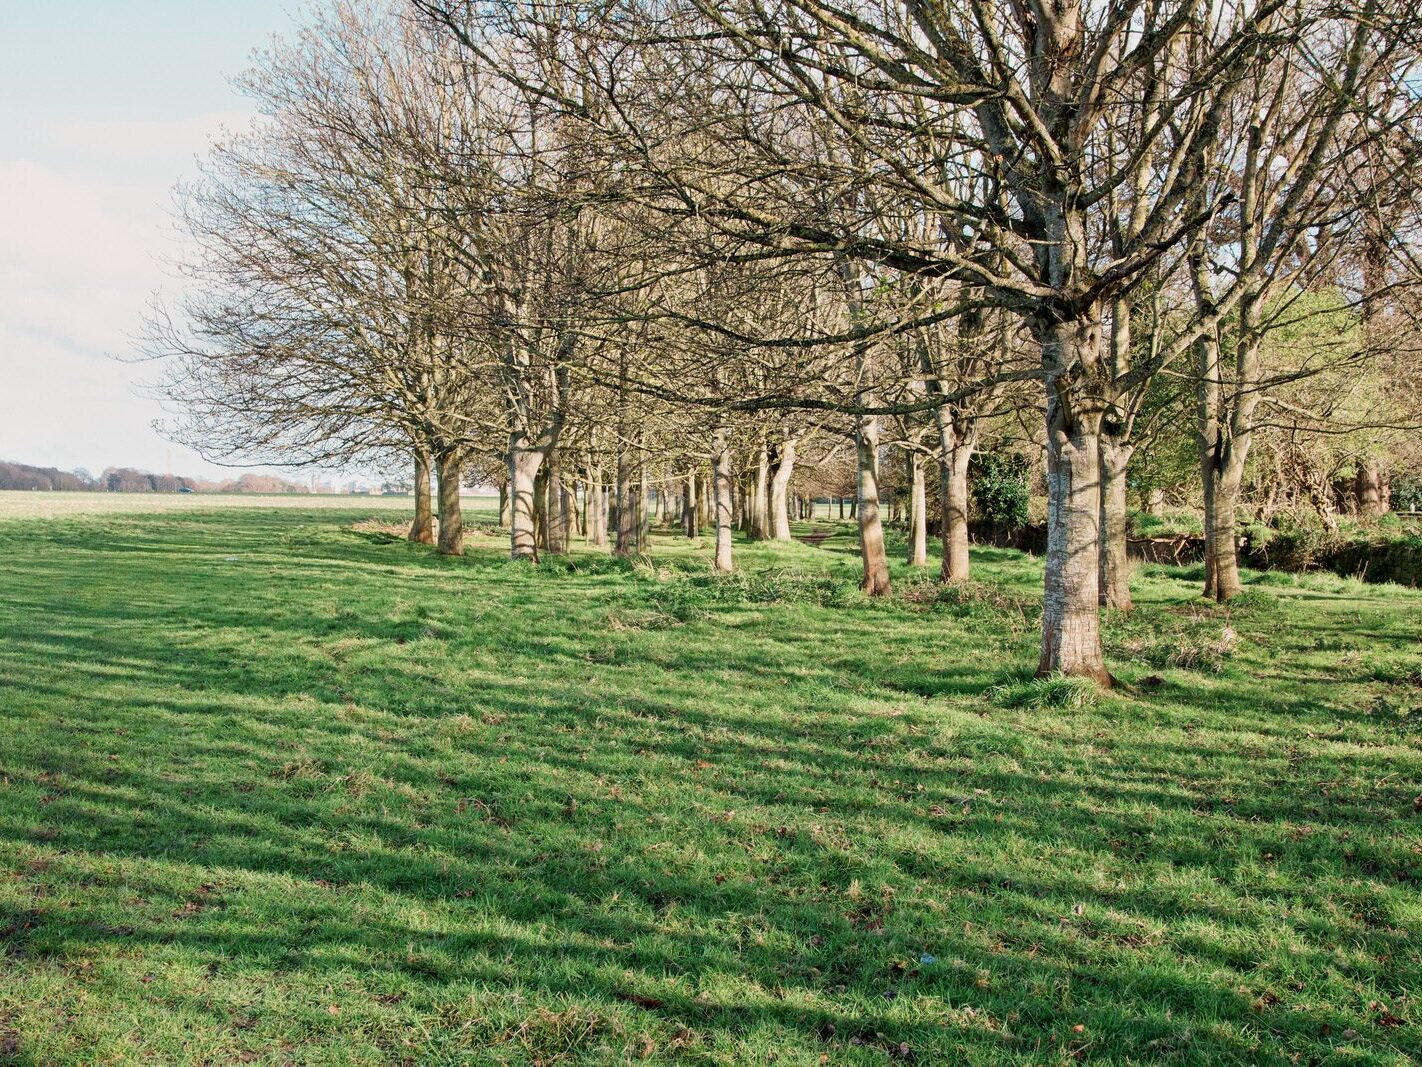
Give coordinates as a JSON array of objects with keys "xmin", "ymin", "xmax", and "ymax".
[{"xmin": 151, "ymin": 0, "xmax": 1422, "ymax": 683}]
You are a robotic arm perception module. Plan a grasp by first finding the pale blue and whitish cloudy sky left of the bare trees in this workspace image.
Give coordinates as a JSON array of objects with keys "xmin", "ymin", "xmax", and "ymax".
[{"xmin": 0, "ymin": 0, "xmax": 312, "ymax": 477}]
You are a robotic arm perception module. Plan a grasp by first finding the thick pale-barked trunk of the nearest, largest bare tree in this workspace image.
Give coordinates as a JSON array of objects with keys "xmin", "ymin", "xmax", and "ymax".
[{"xmin": 1035, "ymin": 319, "xmax": 1111, "ymax": 686}]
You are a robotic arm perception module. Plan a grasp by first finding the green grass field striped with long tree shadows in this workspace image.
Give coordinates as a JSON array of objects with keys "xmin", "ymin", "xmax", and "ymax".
[{"xmin": 0, "ymin": 498, "xmax": 1422, "ymax": 1064}]
